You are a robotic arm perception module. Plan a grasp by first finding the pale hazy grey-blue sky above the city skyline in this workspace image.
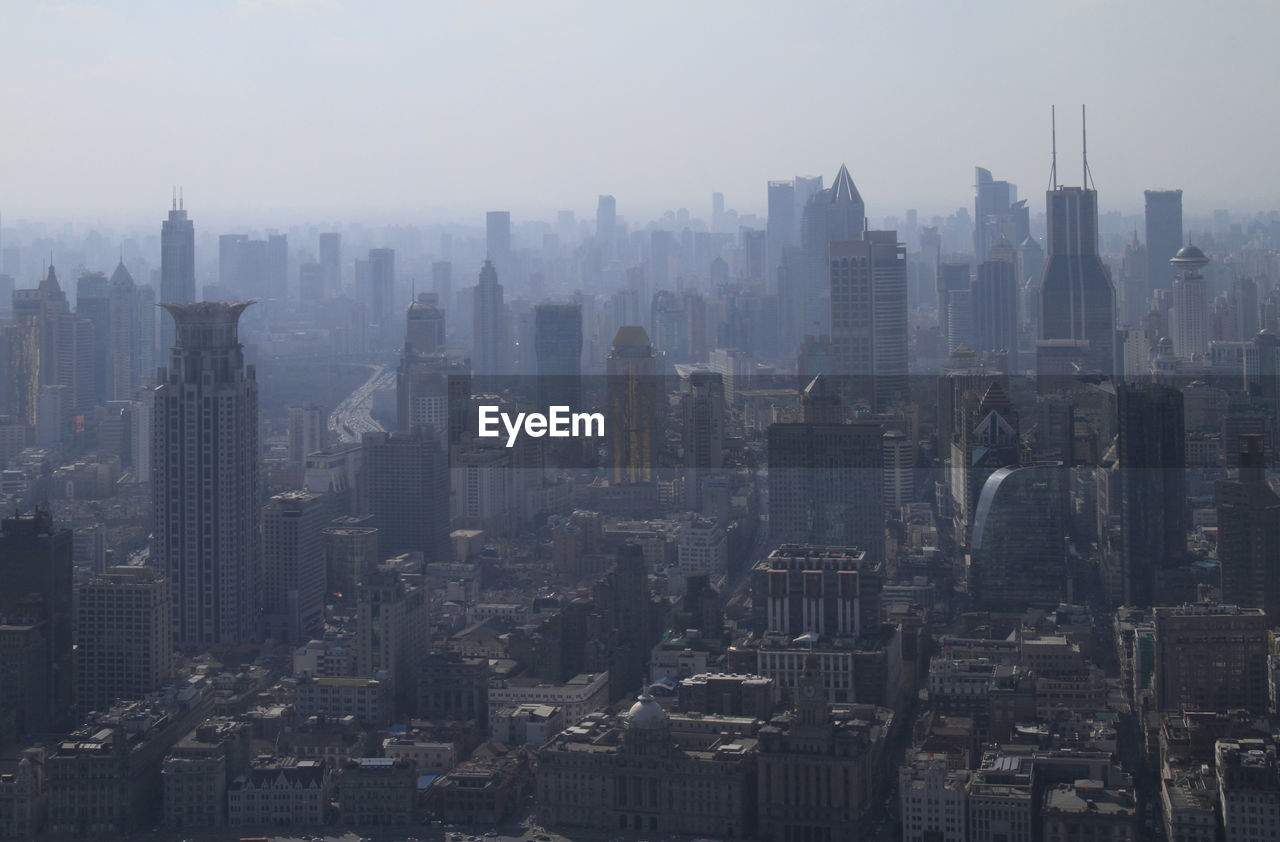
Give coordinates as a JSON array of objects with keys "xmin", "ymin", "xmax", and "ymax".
[{"xmin": 0, "ymin": 0, "xmax": 1280, "ymax": 223}]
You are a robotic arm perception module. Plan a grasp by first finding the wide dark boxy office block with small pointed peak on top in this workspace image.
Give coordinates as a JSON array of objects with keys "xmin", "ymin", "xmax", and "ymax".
[{"xmin": 768, "ymin": 375, "xmax": 884, "ymax": 559}]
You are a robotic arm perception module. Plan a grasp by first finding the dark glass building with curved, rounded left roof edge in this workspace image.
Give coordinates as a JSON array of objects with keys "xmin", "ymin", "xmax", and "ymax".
[{"xmin": 969, "ymin": 465, "xmax": 1071, "ymax": 612}]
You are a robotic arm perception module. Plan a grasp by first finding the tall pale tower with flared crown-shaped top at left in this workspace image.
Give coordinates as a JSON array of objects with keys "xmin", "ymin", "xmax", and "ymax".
[{"xmin": 151, "ymin": 301, "xmax": 262, "ymax": 649}]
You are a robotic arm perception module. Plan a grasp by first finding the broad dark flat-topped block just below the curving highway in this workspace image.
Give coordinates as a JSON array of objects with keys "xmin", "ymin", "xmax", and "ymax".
[{"xmin": 361, "ymin": 426, "xmax": 449, "ymax": 560}]
